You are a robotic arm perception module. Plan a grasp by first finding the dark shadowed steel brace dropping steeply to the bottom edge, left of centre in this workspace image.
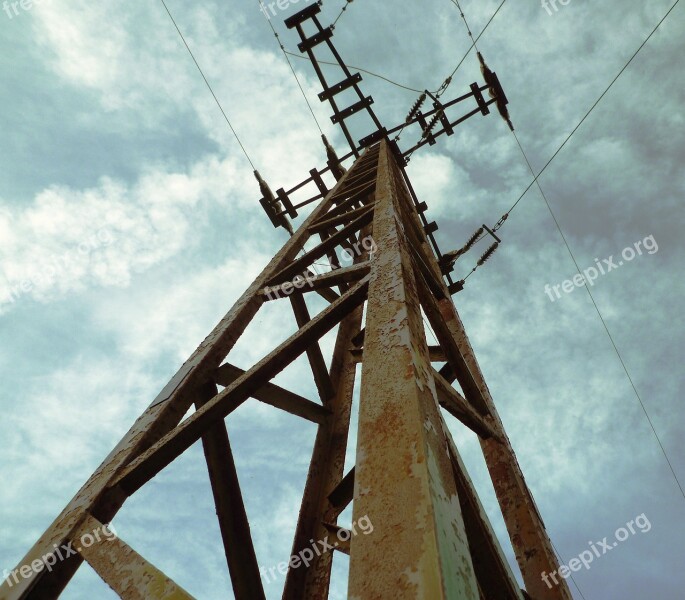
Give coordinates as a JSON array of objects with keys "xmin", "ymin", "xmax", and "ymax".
[{"xmin": 195, "ymin": 383, "xmax": 266, "ymax": 600}]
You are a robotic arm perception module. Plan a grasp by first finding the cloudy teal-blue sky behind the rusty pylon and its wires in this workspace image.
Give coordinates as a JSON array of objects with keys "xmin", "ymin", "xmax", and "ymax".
[{"xmin": 0, "ymin": 0, "xmax": 685, "ymax": 600}]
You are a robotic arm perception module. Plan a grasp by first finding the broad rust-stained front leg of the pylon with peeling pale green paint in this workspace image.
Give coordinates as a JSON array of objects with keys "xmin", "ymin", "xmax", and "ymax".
[{"xmin": 349, "ymin": 142, "xmax": 479, "ymax": 600}]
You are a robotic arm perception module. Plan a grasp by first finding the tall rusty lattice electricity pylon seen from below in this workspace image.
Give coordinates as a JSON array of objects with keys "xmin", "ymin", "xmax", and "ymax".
[{"xmin": 0, "ymin": 5, "xmax": 571, "ymax": 600}]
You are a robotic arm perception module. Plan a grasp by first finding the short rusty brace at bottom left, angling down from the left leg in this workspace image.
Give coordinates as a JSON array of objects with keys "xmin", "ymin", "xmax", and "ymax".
[{"xmin": 76, "ymin": 516, "xmax": 193, "ymax": 600}]
